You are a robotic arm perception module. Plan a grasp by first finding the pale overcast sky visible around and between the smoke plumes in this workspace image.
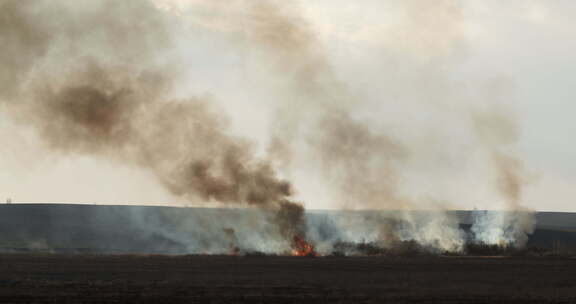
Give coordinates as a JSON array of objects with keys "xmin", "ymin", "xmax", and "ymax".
[{"xmin": 0, "ymin": 0, "xmax": 576, "ymax": 212}]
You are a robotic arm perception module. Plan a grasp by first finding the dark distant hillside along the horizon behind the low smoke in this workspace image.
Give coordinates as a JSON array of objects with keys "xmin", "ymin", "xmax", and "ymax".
[{"xmin": 0, "ymin": 204, "xmax": 576, "ymax": 254}]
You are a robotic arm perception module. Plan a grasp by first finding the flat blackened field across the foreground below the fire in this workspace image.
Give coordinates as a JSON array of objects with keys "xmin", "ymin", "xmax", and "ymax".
[{"xmin": 0, "ymin": 254, "xmax": 576, "ymax": 303}]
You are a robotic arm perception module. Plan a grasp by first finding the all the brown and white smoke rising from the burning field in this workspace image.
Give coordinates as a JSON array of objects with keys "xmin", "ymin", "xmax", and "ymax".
[{"xmin": 0, "ymin": 0, "xmax": 532, "ymax": 252}]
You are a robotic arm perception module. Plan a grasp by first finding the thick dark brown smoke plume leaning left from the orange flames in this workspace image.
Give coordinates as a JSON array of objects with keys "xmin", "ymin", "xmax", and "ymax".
[{"xmin": 0, "ymin": 0, "xmax": 306, "ymax": 254}]
